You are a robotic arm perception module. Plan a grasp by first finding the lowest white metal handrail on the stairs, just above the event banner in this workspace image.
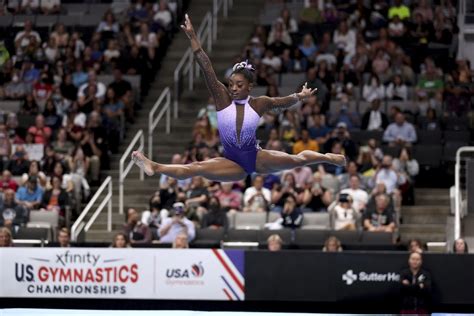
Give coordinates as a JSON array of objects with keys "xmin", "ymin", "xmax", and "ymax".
[{"xmin": 71, "ymin": 176, "xmax": 112, "ymax": 241}]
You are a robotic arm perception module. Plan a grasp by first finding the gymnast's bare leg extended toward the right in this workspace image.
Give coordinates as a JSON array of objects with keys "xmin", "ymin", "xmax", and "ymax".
[{"xmin": 257, "ymin": 149, "xmax": 346, "ymax": 173}]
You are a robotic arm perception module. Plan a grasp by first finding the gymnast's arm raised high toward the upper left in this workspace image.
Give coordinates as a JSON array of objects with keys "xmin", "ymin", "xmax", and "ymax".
[{"xmin": 181, "ymin": 14, "xmax": 232, "ymax": 110}]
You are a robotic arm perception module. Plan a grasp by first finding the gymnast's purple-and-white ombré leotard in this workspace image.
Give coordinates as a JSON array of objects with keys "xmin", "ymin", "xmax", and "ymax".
[{"xmin": 217, "ymin": 97, "xmax": 260, "ymax": 174}]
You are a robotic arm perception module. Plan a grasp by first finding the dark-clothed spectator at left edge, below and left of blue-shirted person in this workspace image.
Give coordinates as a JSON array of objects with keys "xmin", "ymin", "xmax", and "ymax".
[{"xmin": 0, "ymin": 189, "xmax": 29, "ymax": 229}]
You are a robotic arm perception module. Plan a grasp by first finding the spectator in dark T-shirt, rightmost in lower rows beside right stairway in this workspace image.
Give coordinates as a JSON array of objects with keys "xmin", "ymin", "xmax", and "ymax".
[{"xmin": 364, "ymin": 194, "xmax": 395, "ymax": 233}]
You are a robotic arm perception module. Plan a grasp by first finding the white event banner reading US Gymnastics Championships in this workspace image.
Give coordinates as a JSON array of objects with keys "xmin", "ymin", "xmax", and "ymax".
[{"xmin": 0, "ymin": 248, "xmax": 245, "ymax": 300}]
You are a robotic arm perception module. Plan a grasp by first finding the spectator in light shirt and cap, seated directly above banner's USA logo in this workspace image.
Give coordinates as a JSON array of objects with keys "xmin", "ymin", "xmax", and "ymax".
[{"xmin": 159, "ymin": 202, "xmax": 196, "ymax": 243}]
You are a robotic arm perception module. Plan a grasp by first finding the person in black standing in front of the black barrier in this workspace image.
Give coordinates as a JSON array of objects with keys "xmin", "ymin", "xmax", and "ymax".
[{"xmin": 400, "ymin": 252, "xmax": 431, "ymax": 314}]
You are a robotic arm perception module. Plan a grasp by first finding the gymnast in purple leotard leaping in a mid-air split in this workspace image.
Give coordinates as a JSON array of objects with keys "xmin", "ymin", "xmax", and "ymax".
[{"xmin": 132, "ymin": 14, "xmax": 346, "ymax": 182}]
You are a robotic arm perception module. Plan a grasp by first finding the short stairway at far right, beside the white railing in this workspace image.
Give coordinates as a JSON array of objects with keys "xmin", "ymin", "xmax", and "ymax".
[{"xmin": 400, "ymin": 188, "xmax": 450, "ymax": 242}]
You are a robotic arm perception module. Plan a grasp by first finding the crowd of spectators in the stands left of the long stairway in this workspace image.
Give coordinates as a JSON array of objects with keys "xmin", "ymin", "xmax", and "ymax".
[{"xmin": 0, "ymin": 0, "xmax": 177, "ymax": 233}]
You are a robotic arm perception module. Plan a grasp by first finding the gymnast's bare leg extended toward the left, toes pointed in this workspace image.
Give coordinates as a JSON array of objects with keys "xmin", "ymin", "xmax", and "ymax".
[{"xmin": 132, "ymin": 151, "xmax": 247, "ymax": 181}]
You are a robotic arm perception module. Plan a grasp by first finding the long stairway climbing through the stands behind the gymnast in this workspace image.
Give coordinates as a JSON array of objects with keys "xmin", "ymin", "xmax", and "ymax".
[{"xmin": 85, "ymin": 0, "xmax": 263, "ymax": 242}]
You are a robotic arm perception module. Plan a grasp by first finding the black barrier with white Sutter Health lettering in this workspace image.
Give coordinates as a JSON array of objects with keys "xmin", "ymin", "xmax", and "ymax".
[{"xmin": 245, "ymin": 251, "xmax": 474, "ymax": 307}]
